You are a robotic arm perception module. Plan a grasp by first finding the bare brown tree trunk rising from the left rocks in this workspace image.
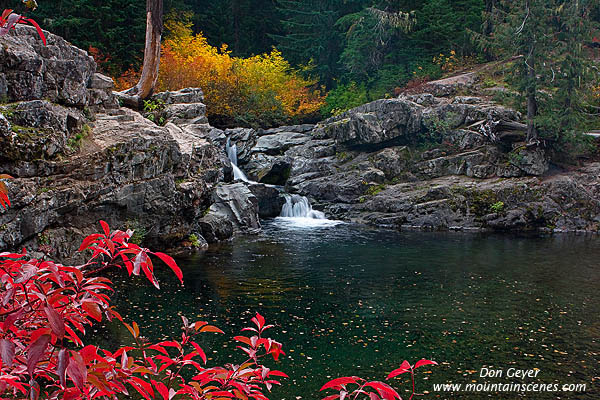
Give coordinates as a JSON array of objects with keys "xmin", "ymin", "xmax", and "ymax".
[{"xmin": 119, "ymin": 0, "xmax": 163, "ymax": 108}]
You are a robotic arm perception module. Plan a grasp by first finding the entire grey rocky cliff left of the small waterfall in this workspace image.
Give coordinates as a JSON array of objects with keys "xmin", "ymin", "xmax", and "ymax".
[{"xmin": 0, "ymin": 27, "xmax": 260, "ymax": 257}]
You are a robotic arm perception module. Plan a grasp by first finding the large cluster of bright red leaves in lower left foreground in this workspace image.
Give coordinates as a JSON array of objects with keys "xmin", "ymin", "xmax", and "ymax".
[{"xmin": 0, "ymin": 219, "xmax": 287, "ymax": 400}]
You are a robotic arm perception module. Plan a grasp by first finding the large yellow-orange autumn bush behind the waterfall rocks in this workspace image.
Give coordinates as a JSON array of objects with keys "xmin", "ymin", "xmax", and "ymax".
[{"xmin": 158, "ymin": 27, "xmax": 323, "ymax": 126}]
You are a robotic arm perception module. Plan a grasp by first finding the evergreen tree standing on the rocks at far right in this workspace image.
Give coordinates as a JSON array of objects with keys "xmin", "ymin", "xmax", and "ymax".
[{"xmin": 483, "ymin": 0, "xmax": 597, "ymax": 143}]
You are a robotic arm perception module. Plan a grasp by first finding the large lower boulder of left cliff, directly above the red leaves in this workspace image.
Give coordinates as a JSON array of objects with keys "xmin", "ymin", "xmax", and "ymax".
[{"xmin": 0, "ymin": 109, "xmax": 227, "ymax": 257}]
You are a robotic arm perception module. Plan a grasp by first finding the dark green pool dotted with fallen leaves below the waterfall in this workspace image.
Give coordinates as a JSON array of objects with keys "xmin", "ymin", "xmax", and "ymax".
[{"xmin": 96, "ymin": 223, "xmax": 600, "ymax": 400}]
